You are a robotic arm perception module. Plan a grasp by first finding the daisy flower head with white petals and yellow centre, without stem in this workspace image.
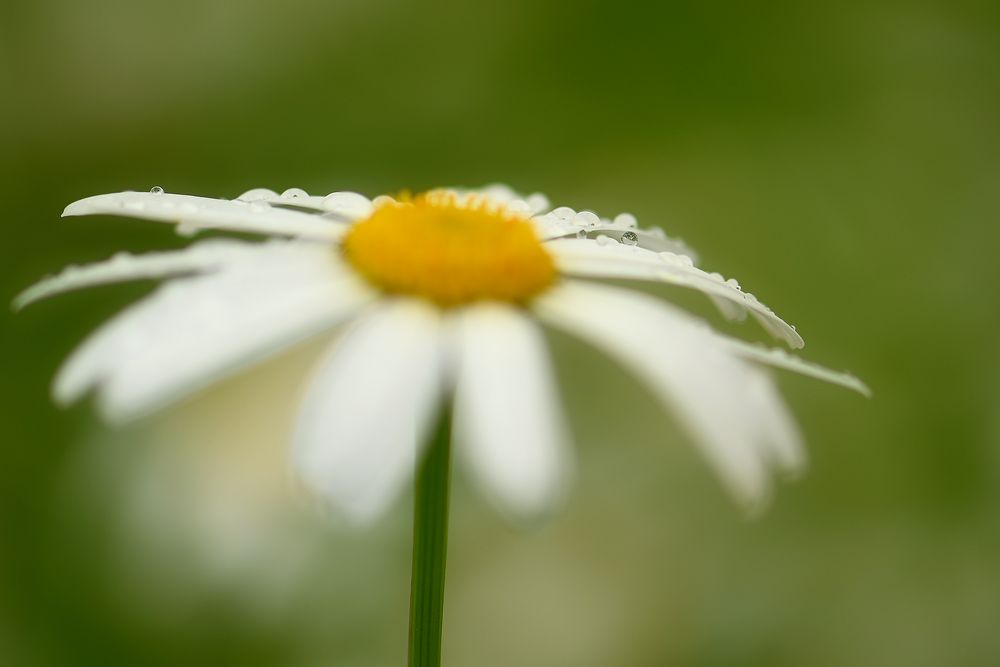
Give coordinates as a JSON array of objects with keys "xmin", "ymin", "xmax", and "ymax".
[{"xmin": 21, "ymin": 186, "xmax": 867, "ymax": 519}]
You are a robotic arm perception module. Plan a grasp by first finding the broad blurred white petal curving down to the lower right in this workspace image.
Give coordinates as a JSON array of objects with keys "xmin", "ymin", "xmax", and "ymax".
[{"xmin": 535, "ymin": 282, "xmax": 784, "ymax": 508}]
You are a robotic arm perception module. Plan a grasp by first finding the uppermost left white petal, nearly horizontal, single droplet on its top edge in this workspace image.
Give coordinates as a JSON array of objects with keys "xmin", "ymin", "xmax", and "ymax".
[{"xmin": 63, "ymin": 192, "xmax": 347, "ymax": 240}]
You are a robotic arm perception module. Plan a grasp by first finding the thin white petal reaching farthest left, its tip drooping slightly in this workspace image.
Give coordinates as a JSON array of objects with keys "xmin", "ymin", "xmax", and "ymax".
[{"xmin": 14, "ymin": 239, "xmax": 260, "ymax": 309}]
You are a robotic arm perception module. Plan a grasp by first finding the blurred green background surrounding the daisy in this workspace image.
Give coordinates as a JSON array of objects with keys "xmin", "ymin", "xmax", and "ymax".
[{"xmin": 0, "ymin": 0, "xmax": 1000, "ymax": 667}]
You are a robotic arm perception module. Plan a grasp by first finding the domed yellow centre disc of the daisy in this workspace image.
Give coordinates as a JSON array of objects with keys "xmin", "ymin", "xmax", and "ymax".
[{"xmin": 342, "ymin": 190, "xmax": 556, "ymax": 307}]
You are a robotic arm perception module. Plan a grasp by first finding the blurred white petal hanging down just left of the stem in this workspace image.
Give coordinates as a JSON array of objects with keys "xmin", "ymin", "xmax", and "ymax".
[{"xmin": 295, "ymin": 300, "xmax": 443, "ymax": 521}]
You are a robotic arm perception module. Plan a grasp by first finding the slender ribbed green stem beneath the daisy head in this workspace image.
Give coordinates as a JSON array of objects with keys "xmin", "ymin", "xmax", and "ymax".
[{"xmin": 410, "ymin": 410, "xmax": 451, "ymax": 667}]
